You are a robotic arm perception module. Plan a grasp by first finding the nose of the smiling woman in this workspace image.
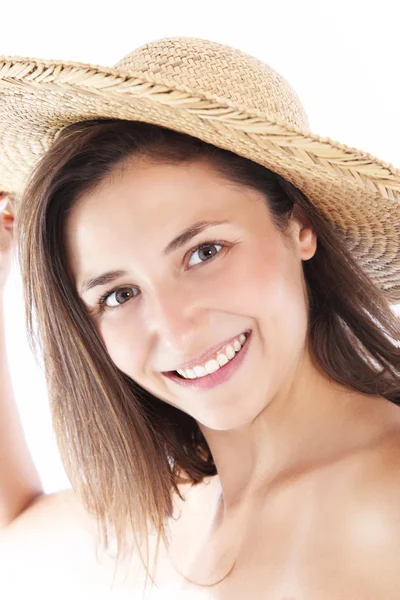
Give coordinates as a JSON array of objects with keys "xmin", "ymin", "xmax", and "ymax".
[{"xmin": 144, "ymin": 286, "xmax": 205, "ymax": 354}]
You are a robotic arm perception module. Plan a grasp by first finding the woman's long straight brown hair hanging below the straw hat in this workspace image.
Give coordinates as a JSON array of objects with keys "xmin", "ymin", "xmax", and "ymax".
[{"xmin": 16, "ymin": 120, "xmax": 400, "ymax": 588}]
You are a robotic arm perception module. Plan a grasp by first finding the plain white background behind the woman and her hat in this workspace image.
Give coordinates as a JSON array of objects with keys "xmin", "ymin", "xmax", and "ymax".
[{"xmin": 0, "ymin": 0, "xmax": 400, "ymax": 492}]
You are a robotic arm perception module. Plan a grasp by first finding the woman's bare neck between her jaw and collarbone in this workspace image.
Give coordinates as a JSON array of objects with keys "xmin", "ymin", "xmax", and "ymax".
[{"xmin": 200, "ymin": 355, "xmax": 382, "ymax": 511}]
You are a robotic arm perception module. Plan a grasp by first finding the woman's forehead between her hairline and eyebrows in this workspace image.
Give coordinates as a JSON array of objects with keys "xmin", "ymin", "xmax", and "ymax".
[{"xmin": 66, "ymin": 159, "xmax": 266, "ymax": 280}]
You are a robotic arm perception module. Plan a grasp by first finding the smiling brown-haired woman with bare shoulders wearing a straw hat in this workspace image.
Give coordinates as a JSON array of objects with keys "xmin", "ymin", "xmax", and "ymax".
[{"xmin": 0, "ymin": 38, "xmax": 400, "ymax": 600}]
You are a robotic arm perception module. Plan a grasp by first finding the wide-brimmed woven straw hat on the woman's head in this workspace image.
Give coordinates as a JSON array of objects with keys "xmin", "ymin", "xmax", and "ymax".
[{"xmin": 0, "ymin": 38, "xmax": 400, "ymax": 301}]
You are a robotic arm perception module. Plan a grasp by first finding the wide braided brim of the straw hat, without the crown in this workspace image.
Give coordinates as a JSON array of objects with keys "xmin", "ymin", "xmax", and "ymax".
[{"xmin": 0, "ymin": 57, "xmax": 400, "ymax": 302}]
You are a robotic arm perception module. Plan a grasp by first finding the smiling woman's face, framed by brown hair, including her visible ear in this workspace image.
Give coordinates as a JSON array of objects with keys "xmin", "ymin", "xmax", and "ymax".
[{"xmin": 66, "ymin": 159, "xmax": 316, "ymax": 430}]
